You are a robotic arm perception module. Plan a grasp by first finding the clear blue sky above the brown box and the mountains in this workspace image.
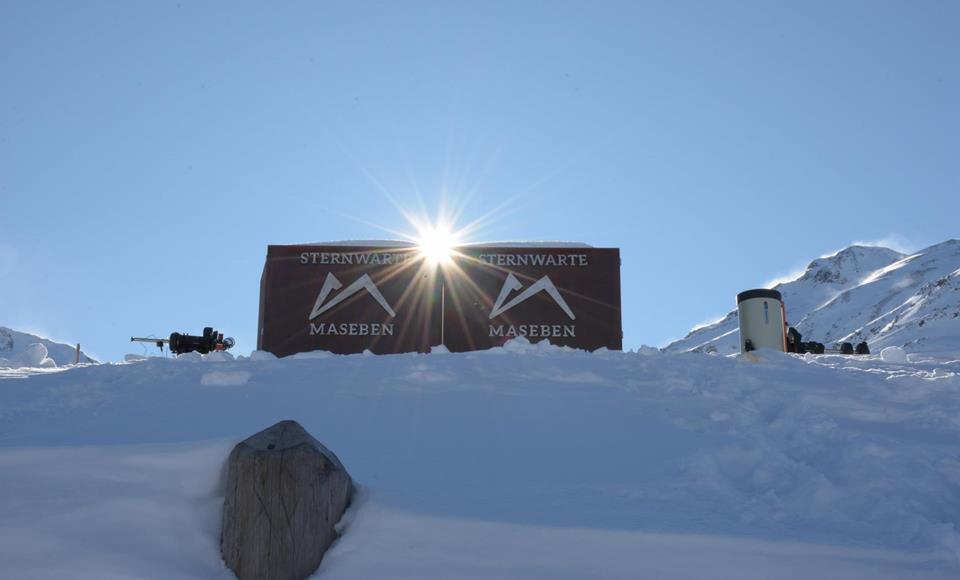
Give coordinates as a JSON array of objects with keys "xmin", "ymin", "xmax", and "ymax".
[{"xmin": 0, "ymin": 0, "xmax": 960, "ymax": 360}]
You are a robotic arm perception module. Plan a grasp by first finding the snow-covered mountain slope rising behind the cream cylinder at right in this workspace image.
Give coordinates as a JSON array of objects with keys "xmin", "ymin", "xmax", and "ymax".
[{"xmin": 666, "ymin": 240, "xmax": 960, "ymax": 354}]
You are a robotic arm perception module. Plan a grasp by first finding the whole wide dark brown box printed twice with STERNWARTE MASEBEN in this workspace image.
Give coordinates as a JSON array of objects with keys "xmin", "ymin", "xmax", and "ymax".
[{"xmin": 258, "ymin": 245, "xmax": 622, "ymax": 356}]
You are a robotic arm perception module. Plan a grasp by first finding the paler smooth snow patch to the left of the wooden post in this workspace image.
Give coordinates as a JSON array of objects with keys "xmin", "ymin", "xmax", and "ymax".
[{"xmin": 0, "ymin": 441, "xmax": 234, "ymax": 580}]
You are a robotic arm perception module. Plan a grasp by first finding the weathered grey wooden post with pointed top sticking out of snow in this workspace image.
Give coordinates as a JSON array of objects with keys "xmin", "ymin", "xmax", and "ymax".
[{"xmin": 220, "ymin": 421, "xmax": 353, "ymax": 580}]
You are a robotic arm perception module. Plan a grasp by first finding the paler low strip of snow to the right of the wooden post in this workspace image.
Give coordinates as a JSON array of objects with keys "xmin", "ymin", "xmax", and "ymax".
[{"xmin": 324, "ymin": 503, "xmax": 951, "ymax": 580}]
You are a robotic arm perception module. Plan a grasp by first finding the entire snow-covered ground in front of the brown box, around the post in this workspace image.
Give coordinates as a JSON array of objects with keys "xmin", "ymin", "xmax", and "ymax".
[{"xmin": 0, "ymin": 341, "xmax": 960, "ymax": 579}]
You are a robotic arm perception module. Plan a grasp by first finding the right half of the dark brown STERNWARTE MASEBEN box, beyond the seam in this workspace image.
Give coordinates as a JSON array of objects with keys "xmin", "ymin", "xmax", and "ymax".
[{"xmin": 443, "ymin": 246, "xmax": 623, "ymax": 351}]
